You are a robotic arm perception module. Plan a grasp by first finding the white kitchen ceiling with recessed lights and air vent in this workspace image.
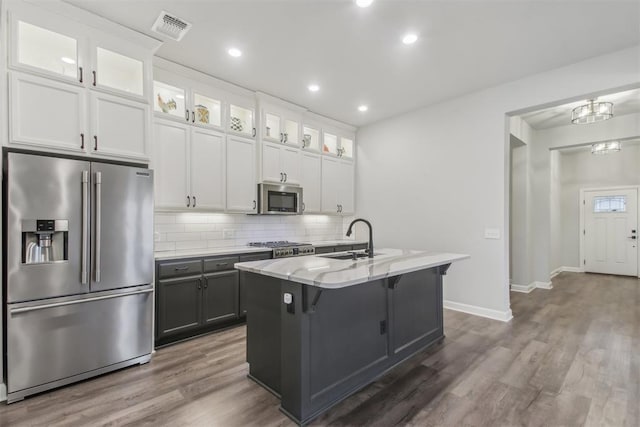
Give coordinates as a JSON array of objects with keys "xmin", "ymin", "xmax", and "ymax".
[{"xmin": 69, "ymin": 0, "xmax": 640, "ymax": 125}]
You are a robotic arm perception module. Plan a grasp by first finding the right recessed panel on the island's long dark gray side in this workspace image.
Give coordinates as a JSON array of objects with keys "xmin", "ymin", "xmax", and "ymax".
[{"xmin": 389, "ymin": 267, "xmax": 444, "ymax": 359}]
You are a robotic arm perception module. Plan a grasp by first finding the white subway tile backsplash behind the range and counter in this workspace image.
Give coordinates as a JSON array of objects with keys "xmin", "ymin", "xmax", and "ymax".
[{"xmin": 155, "ymin": 212, "xmax": 352, "ymax": 251}]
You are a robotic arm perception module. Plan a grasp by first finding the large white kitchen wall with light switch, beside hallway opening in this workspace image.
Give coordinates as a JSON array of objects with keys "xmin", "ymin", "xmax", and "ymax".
[{"xmin": 356, "ymin": 46, "xmax": 640, "ymax": 319}]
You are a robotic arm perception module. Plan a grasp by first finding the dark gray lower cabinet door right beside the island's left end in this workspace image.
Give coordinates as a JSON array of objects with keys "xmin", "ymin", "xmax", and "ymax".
[{"xmin": 202, "ymin": 270, "xmax": 239, "ymax": 325}]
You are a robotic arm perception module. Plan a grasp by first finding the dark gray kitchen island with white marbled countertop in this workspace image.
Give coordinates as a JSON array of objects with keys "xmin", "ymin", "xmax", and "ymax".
[{"xmin": 235, "ymin": 249, "xmax": 468, "ymax": 424}]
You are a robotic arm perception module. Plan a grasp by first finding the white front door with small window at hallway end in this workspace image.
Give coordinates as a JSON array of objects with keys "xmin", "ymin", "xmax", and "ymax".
[{"xmin": 583, "ymin": 188, "xmax": 638, "ymax": 276}]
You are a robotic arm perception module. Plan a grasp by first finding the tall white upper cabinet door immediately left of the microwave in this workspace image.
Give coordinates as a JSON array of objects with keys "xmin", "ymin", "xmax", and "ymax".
[{"xmin": 227, "ymin": 136, "xmax": 258, "ymax": 213}]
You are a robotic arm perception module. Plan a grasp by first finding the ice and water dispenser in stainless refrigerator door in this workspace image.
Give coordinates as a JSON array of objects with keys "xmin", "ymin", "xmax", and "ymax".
[{"xmin": 22, "ymin": 219, "xmax": 69, "ymax": 264}]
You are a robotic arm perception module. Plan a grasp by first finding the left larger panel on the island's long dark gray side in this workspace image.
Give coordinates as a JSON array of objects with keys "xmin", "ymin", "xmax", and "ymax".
[{"xmin": 282, "ymin": 279, "xmax": 389, "ymax": 422}]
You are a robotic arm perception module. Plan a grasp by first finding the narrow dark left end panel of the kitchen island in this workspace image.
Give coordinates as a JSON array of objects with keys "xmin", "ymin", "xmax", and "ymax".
[{"xmin": 246, "ymin": 271, "xmax": 282, "ymax": 395}]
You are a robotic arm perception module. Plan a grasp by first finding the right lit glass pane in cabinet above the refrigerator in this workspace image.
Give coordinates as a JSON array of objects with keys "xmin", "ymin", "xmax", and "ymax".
[{"xmin": 96, "ymin": 47, "xmax": 144, "ymax": 95}]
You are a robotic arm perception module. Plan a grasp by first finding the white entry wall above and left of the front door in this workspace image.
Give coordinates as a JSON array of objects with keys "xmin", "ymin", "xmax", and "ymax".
[{"xmin": 556, "ymin": 144, "xmax": 640, "ymax": 268}]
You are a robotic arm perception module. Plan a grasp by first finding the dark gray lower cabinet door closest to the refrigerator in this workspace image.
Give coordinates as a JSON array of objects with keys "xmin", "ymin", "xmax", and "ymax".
[{"xmin": 156, "ymin": 276, "xmax": 202, "ymax": 338}]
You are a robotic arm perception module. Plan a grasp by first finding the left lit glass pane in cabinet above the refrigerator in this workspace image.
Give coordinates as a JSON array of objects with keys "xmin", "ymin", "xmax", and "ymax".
[{"xmin": 18, "ymin": 21, "xmax": 78, "ymax": 79}]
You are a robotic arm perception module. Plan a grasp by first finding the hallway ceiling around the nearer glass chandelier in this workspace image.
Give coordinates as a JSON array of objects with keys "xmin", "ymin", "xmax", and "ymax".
[{"xmin": 520, "ymin": 89, "xmax": 640, "ymax": 129}]
